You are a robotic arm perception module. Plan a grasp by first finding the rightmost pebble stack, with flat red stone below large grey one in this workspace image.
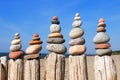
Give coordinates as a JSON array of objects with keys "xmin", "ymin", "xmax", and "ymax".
[{"xmin": 93, "ymin": 18, "xmax": 112, "ymax": 56}]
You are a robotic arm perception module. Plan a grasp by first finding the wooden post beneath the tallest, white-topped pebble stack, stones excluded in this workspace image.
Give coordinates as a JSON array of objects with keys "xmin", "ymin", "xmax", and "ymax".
[{"xmin": 69, "ymin": 54, "xmax": 88, "ymax": 80}]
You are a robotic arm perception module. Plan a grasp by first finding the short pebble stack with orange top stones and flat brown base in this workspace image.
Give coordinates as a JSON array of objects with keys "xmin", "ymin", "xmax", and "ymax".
[{"xmin": 24, "ymin": 34, "xmax": 43, "ymax": 60}]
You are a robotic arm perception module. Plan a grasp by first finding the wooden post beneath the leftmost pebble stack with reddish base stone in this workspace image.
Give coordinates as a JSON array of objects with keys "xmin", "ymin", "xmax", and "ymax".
[{"xmin": 8, "ymin": 59, "xmax": 23, "ymax": 80}]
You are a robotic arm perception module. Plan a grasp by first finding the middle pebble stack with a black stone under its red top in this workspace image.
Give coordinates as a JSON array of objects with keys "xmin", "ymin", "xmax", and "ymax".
[{"xmin": 46, "ymin": 16, "xmax": 66, "ymax": 54}]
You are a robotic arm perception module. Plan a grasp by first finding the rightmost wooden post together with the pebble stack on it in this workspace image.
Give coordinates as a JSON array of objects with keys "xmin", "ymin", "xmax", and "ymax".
[{"xmin": 93, "ymin": 18, "xmax": 117, "ymax": 80}]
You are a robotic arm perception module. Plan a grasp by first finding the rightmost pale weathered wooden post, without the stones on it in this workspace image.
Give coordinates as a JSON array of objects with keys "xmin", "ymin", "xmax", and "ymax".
[{"xmin": 94, "ymin": 56, "xmax": 117, "ymax": 80}]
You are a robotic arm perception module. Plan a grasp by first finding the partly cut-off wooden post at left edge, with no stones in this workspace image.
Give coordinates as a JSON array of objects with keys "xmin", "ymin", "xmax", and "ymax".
[{"xmin": 0, "ymin": 56, "xmax": 7, "ymax": 80}]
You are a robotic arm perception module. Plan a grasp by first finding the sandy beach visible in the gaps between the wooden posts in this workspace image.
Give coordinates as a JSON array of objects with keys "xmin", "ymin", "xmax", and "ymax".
[{"xmin": 40, "ymin": 55, "xmax": 120, "ymax": 80}]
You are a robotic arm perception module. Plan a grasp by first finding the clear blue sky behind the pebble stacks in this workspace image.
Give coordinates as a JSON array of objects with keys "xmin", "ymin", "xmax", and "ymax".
[{"xmin": 0, "ymin": 0, "xmax": 120, "ymax": 54}]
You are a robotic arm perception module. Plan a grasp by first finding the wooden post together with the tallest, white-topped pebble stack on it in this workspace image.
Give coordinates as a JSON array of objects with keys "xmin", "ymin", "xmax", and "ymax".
[{"xmin": 69, "ymin": 13, "xmax": 88, "ymax": 80}]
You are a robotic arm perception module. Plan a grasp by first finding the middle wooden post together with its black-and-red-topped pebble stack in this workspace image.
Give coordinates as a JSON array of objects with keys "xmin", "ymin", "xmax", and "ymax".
[{"xmin": 44, "ymin": 16, "xmax": 66, "ymax": 80}]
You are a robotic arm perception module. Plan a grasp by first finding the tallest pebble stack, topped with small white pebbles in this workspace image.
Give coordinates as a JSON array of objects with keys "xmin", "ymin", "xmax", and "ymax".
[{"xmin": 69, "ymin": 13, "xmax": 86, "ymax": 55}]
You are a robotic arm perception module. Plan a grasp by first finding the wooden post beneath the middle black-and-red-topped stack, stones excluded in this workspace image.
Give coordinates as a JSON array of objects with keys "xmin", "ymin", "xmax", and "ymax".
[{"xmin": 44, "ymin": 52, "xmax": 65, "ymax": 80}]
